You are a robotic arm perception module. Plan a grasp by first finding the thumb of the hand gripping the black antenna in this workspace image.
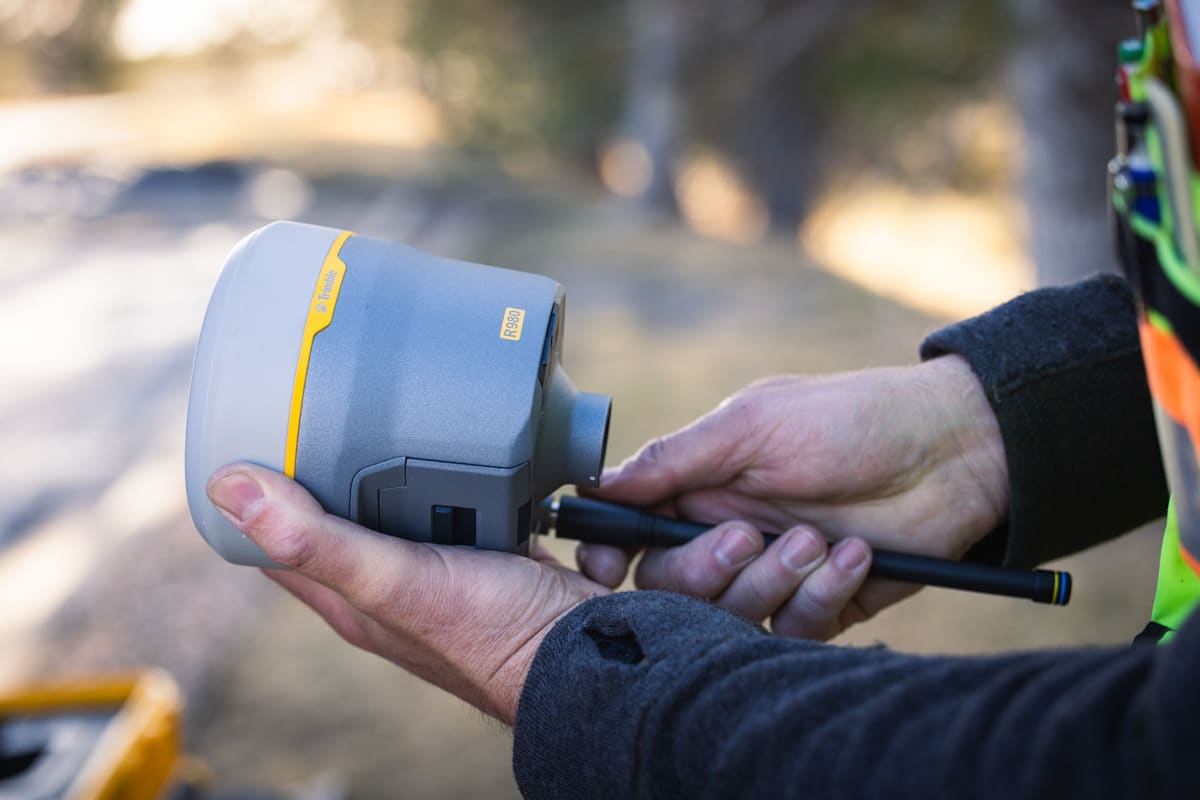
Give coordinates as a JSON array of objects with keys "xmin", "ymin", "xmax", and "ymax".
[{"xmin": 588, "ymin": 404, "xmax": 749, "ymax": 506}]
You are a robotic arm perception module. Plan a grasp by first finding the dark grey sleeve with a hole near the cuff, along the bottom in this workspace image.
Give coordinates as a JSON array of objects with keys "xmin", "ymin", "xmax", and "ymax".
[{"xmin": 514, "ymin": 591, "xmax": 1200, "ymax": 800}]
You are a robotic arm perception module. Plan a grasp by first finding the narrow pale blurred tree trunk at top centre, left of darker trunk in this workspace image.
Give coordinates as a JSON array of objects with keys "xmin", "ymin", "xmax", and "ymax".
[{"xmin": 622, "ymin": 0, "xmax": 688, "ymax": 216}]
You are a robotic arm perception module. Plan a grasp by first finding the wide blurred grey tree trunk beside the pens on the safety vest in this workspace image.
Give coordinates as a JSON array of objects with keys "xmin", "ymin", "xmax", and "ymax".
[{"xmin": 1013, "ymin": 0, "xmax": 1136, "ymax": 285}]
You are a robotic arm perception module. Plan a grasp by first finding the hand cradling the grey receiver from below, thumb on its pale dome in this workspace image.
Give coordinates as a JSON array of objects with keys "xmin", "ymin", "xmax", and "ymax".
[{"xmin": 208, "ymin": 464, "xmax": 608, "ymax": 724}]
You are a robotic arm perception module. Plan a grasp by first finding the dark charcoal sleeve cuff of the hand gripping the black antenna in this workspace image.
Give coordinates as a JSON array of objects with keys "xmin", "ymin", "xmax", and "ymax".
[{"xmin": 920, "ymin": 275, "xmax": 1166, "ymax": 566}]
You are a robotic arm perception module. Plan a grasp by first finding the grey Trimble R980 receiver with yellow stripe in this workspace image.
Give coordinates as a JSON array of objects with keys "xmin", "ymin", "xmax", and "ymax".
[{"xmin": 186, "ymin": 222, "xmax": 611, "ymax": 566}]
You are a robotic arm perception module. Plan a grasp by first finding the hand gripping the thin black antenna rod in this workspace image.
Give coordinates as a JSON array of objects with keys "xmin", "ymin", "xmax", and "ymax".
[{"xmin": 577, "ymin": 356, "xmax": 1008, "ymax": 638}]
